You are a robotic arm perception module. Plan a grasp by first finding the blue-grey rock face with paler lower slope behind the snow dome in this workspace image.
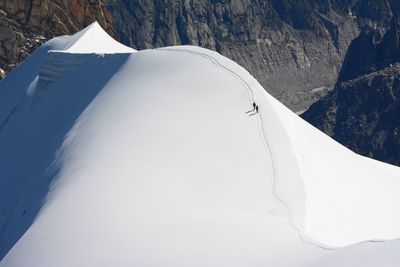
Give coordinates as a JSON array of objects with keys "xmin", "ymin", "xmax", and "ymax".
[{"xmin": 107, "ymin": 0, "xmax": 392, "ymax": 111}]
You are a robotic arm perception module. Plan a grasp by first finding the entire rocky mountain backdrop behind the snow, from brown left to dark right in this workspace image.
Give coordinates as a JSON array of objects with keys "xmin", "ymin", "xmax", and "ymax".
[{"xmin": 0, "ymin": 0, "xmax": 400, "ymax": 165}]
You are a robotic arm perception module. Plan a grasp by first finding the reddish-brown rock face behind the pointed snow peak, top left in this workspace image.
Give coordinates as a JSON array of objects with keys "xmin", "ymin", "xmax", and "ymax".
[{"xmin": 0, "ymin": 0, "xmax": 113, "ymax": 72}]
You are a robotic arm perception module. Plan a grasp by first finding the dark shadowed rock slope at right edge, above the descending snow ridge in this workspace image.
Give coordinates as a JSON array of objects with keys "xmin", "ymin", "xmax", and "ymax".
[{"xmin": 302, "ymin": 9, "xmax": 400, "ymax": 165}]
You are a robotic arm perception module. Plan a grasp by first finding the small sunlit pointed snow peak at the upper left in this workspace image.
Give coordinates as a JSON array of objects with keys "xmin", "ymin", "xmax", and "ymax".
[{"xmin": 58, "ymin": 21, "xmax": 136, "ymax": 54}]
